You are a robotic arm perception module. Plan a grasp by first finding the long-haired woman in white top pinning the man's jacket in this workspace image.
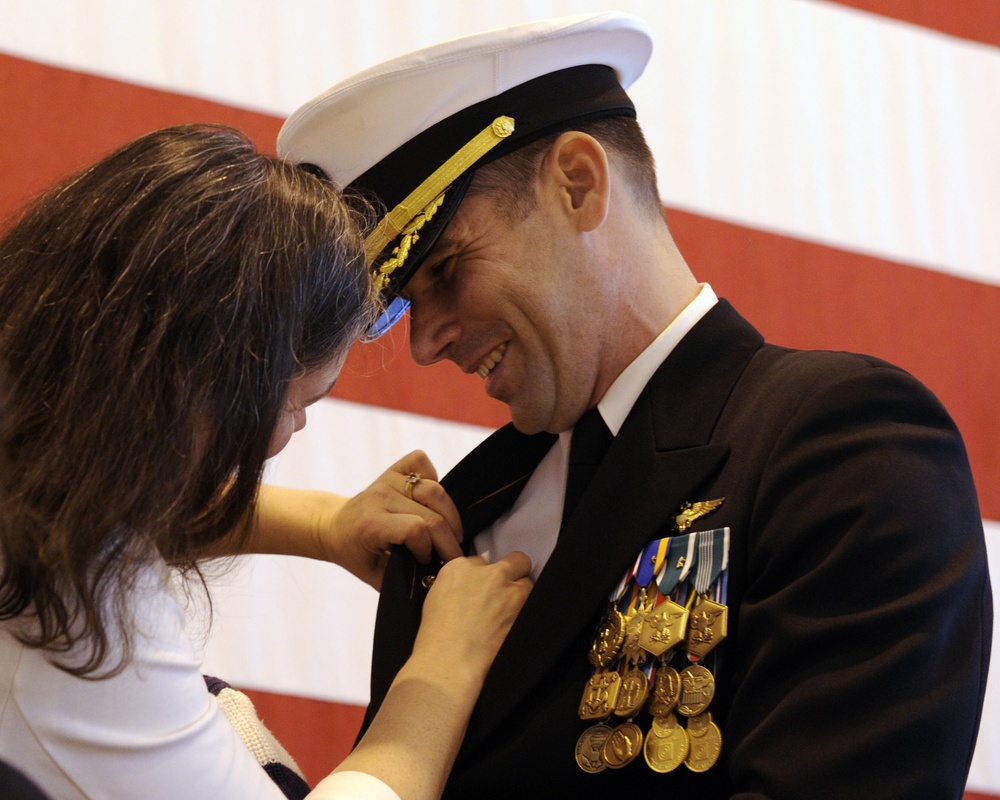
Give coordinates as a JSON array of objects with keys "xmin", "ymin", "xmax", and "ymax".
[{"xmin": 0, "ymin": 126, "xmax": 529, "ymax": 800}]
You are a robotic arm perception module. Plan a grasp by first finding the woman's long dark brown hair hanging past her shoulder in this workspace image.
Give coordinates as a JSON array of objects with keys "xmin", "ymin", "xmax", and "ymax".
[{"xmin": 0, "ymin": 125, "xmax": 377, "ymax": 675}]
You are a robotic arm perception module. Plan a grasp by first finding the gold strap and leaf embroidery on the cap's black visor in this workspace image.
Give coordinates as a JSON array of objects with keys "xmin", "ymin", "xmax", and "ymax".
[{"xmin": 365, "ymin": 111, "xmax": 514, "ymax": 292}]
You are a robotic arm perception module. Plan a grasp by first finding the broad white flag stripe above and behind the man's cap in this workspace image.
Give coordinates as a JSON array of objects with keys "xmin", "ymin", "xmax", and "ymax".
[{"xmin": 0, "ymin": 0, "xmax": 1000, "ymax": 283}]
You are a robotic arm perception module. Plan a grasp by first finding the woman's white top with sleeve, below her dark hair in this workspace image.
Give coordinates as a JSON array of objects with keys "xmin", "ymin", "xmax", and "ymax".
[{"xmin": 0, "ymin": 568, "xmax": 396, "ymax": 800}]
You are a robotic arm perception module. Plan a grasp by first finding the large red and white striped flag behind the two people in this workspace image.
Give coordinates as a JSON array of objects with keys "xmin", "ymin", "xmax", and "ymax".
[{"xmin": 0, "ymin": 0, "xmax": 1000, "ymax": 798}]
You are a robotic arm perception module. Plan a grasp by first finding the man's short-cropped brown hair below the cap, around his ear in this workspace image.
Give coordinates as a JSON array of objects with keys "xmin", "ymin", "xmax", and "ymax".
[{"xmin": 466, "ymin": 115, "xmax": 663, "ymax": 225}]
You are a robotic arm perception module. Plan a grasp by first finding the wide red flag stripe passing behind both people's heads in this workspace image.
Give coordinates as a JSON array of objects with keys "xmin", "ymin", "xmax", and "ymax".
[{"xmin": 7, "ymin": 56, "xmax": 1000, "ymax": 519}]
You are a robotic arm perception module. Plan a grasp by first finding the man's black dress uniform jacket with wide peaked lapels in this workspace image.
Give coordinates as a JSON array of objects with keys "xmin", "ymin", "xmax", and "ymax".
[{"xmin": 356, "ymin": 301, "xmax": 992, "ymax": 800}]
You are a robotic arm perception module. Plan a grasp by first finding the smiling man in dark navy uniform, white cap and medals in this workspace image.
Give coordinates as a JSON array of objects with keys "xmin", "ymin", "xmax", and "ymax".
[{"xmin": 279, "ymin": 13, "xmax": 992, "ymax": 800}]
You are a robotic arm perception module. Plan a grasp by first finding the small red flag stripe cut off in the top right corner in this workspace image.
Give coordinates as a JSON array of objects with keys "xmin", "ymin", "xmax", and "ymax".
[{"xmin": 829, "ymin": 0, "xmax": 1000, "ymax": 46}]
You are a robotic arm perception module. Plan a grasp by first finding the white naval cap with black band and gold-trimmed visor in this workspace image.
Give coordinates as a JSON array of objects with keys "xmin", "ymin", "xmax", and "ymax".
[{"xmin": 278, "ymin": 12, "xmax": 652, "ymax": 338}]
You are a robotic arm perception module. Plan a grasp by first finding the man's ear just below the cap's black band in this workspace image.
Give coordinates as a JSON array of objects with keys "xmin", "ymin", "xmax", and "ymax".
[{"xmin": 542, "ymin": 131, "xmax": 611, "ymax": 232}]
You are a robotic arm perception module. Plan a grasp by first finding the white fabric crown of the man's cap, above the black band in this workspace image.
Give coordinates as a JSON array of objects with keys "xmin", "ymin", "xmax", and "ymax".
[{"xmin": 278, "ymin": 11, "xmax": 653, "ymax": 186}]
